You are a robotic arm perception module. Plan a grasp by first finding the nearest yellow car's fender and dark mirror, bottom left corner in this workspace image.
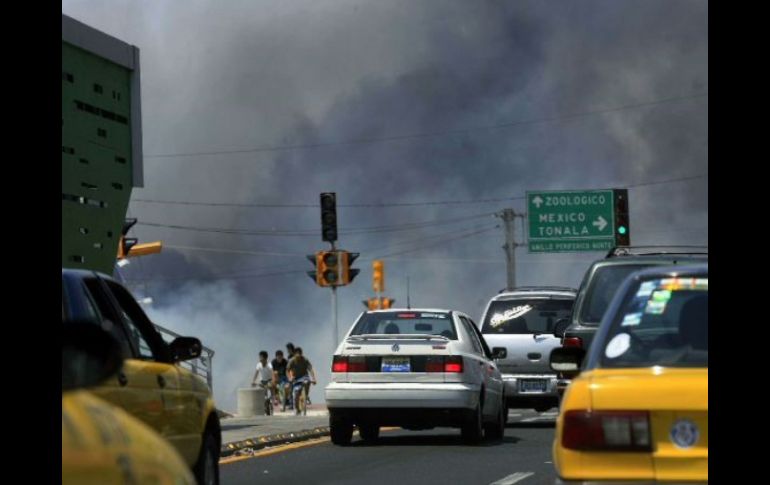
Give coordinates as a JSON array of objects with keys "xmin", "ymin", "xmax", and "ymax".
[{"xmin": 62, "ymin": 323, "xmax": 196, "ymax": 485}]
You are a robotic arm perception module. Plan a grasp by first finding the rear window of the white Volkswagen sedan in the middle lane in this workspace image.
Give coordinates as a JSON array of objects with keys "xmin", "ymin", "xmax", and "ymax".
[{"xmin": 350, "ymin": 311, "xmax": 457, "ymax": 340}]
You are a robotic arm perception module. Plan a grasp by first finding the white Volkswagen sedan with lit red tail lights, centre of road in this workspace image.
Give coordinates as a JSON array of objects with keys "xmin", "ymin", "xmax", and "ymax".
[{"xmin": 326, "ymin": 309, "xmax": 507, "ymax": 445}]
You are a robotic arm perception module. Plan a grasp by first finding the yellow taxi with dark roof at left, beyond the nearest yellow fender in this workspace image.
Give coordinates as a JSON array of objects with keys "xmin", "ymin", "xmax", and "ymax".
[{"xmin": 62, "ymin": 268, "xmax": 221, "ymax": 485}]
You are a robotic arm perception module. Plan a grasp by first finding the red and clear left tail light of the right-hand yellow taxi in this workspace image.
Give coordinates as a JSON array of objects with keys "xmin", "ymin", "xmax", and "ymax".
[{"xmin": 561, "ymin": 411, "xmax": 651, "ymax": 451}]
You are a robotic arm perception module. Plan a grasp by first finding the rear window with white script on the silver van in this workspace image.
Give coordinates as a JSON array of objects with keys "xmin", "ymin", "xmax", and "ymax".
[{"xmin": 481, "ymin": 298, "xmax": 575, "ymax": 334}]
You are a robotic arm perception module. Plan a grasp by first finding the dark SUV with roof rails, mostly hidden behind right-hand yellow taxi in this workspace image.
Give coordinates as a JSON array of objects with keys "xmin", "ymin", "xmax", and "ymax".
[{"xmin": 554, "ymin": 246, "xmax": 708, "ymax": 384}]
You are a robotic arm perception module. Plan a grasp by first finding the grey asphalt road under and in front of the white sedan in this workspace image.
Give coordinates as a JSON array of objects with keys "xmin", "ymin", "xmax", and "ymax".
[{"xmin": 220, "ymin": 409, "xmax": 556, "ymax": 485}]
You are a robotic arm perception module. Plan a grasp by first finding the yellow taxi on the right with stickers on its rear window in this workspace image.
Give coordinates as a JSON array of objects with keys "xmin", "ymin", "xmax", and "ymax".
[{"xmin": 550, "ymin": 264, "xmax": 708, "ymax": 484}]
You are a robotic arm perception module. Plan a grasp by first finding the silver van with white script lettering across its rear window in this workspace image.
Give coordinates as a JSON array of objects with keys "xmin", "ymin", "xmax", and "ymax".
[{"xmin": 481, "ymin": 287, "xmax": 577, "ymax": 412}]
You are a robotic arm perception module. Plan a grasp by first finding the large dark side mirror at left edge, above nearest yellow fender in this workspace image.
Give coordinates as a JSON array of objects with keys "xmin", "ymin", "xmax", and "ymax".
[{"xmin": 61, "ymin": 320, "xmax": 123, "ymax": 392}]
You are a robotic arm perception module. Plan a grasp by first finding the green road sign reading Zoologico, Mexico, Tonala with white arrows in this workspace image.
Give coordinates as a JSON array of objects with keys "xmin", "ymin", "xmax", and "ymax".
[{"xmin": 527, "ymin": 190, "xmax": 615, "ymax": 253}]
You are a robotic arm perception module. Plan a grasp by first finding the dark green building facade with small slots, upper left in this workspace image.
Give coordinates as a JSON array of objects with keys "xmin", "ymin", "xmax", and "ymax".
[{"xmin": 62, "ymin": 15, "xmax": 143, "ymax": 274}]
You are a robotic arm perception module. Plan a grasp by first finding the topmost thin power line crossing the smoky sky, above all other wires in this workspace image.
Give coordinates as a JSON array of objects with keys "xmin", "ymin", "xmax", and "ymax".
[{"xmin": 144, "ymin": 91, "xmax": 708, "ymax": 159}]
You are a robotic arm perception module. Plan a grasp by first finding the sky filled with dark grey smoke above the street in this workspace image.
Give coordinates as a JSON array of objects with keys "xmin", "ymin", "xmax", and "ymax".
[{"xmin": 62, "ymin": 0, "xmax": 708, "ymax": 410}]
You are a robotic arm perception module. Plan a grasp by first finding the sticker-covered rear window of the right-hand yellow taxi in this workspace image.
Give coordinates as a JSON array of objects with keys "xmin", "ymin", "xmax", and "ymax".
[{"xmin": 600, "ymin": 275, "xmax": 708, "ymax": 367}]
